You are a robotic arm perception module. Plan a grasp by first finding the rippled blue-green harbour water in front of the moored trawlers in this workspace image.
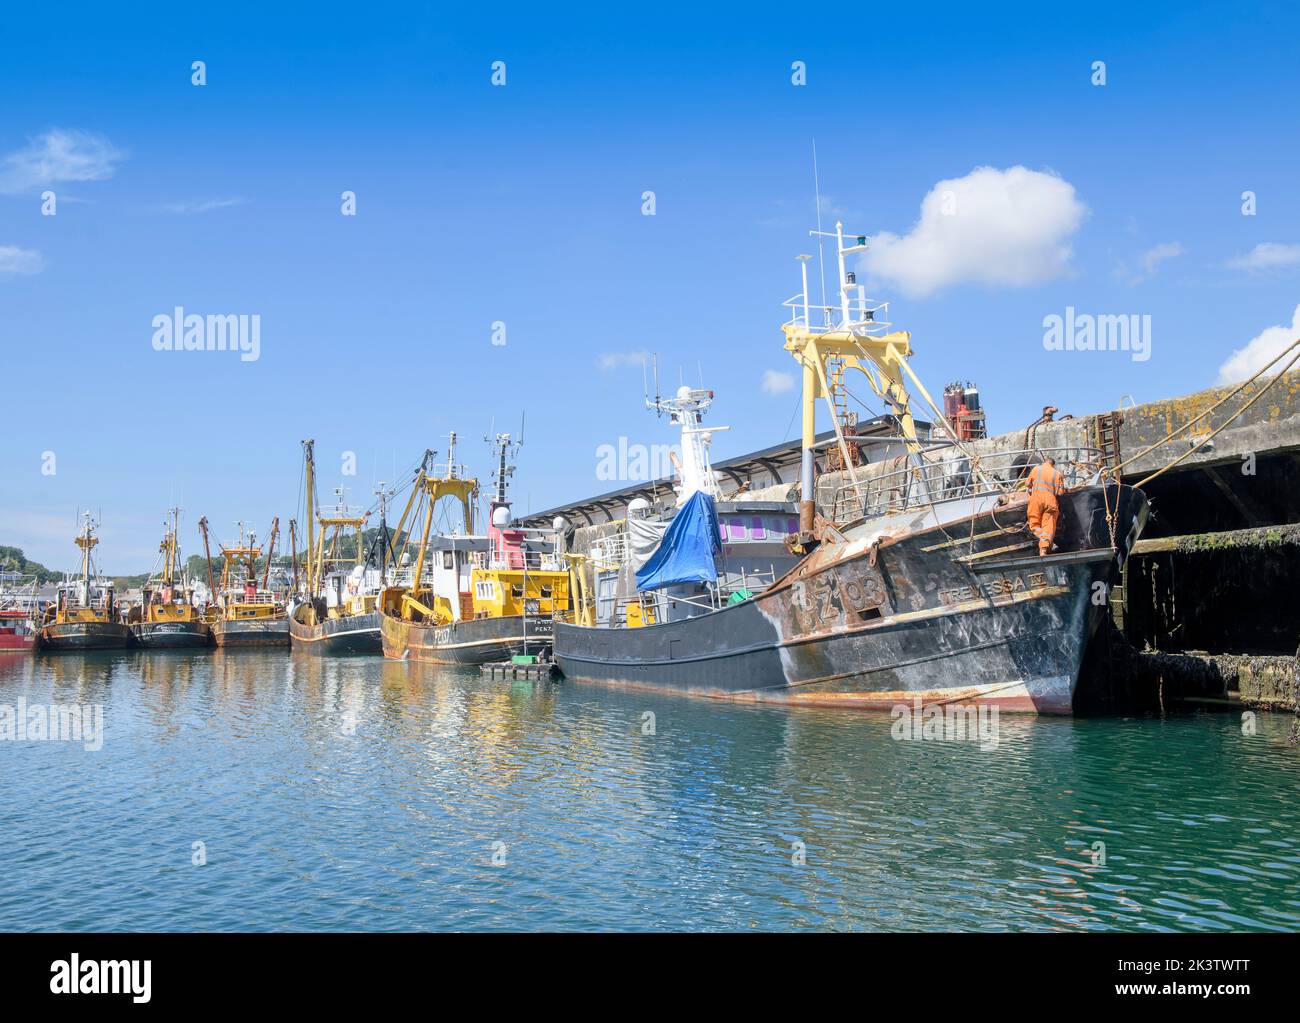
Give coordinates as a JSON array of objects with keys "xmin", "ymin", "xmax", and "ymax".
[{"xmin": 0, "ymin": 650, "xmax": 1300, "ymax": 931}]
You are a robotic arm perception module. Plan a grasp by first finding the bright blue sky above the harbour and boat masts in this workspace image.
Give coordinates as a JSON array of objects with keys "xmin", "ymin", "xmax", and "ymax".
[{"xmin": 0, "ymin": 4, "xmax": 1300, "ymax": 572}]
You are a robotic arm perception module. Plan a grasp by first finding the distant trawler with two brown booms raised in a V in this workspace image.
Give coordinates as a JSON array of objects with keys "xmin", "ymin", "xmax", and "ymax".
[{"xmin": 199, "ymin": 519, "xmax": 289, "ymax": 647}]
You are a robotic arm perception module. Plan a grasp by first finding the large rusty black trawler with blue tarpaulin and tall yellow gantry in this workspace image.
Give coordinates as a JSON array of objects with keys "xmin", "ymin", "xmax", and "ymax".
[{"xmin": 555, "ymin": 224, "xmax": 1148, "ymax": 714}]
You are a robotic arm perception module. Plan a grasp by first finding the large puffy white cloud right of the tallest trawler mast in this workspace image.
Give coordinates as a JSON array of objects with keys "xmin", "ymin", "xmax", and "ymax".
[{"xmin": 862, "ymin": 166, "xmax": 1087, "ymax": 296}]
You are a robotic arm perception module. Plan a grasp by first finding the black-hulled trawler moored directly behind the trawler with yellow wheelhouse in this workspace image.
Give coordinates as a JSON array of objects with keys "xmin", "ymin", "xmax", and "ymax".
[{"xmin": 289, "ymin": 441, "xmax": 387, "ymax": 654}]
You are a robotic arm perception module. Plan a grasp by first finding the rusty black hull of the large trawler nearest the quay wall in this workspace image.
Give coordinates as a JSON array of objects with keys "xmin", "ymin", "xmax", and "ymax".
[{"xmin": 555, "ymin": 486, "xmax": 1147, "ymax": 714}]
